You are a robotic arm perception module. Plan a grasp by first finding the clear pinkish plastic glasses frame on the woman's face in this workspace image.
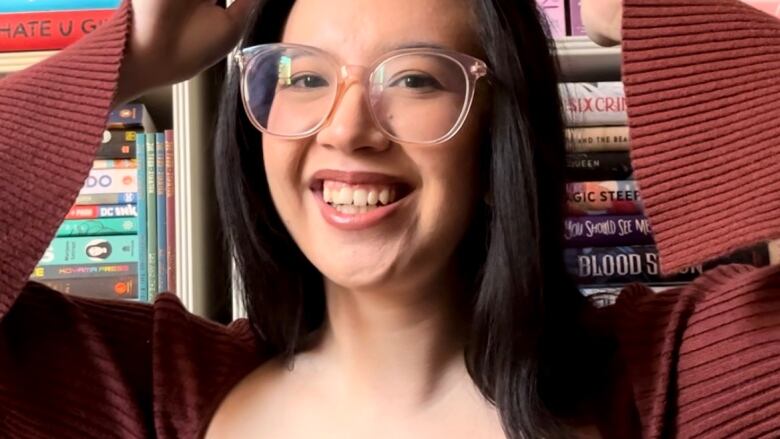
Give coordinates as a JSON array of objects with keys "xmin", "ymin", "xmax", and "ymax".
[{"xmin": 233, "ymin": 43, "xmax": 488, "ymax": 144}]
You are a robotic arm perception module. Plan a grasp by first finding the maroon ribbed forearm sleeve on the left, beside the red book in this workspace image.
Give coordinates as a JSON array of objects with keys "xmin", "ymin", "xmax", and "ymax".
[{"xmin": 0, "ymin": 0, "xmax": 131, "ymax": 317}]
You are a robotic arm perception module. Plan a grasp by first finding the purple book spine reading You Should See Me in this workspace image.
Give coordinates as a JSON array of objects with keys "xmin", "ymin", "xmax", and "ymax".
[{"xmin": 563, "ymin": 215, "xmax": 654, "ymax": 247}]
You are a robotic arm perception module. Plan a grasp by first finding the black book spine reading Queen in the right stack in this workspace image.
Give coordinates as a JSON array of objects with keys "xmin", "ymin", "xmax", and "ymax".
[{"xmin": 566, "ymin": 151, "xmax": 634, "ymax": 181}]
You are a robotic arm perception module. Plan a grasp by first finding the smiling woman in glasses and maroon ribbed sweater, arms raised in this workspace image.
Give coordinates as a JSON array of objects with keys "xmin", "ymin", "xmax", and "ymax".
[{"xmin": 0, "ymin": 0, "xmax": 780, "ymax": 437}]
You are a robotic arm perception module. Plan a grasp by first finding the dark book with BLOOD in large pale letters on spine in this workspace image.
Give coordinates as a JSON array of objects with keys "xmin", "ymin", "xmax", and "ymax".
[{"xmin": 564, "ymin": 244, "xmax": 770, "ymax": 286}]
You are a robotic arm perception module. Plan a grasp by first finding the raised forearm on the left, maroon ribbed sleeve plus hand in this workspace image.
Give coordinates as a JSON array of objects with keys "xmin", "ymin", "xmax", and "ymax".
[{"xmin": 0, "ymin": 0, "xmax": 256, "ymax": 319}]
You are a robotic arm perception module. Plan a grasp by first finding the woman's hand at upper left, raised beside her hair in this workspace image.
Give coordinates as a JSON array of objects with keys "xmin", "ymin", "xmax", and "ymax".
[{"xmin": 115, "ymin": 0, "xmax": 258, "ymax": 103}]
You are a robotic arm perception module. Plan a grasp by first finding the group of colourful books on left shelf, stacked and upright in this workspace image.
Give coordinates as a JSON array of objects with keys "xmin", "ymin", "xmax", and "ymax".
[{"xmin": 31, "ymin": 103, "xmax": 175, "ymax": 301}]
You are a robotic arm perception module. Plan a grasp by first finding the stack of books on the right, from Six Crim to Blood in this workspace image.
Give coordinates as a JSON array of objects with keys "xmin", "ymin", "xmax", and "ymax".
[{"xmin": 561, "ymin": 82, "xmax": 777, "ymax": 305}]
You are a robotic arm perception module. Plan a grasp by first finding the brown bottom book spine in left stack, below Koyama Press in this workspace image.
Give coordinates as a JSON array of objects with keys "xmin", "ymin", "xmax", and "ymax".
[{"xmin": 40, "ymin": 276, "xmax": 139, "ymax": 300}]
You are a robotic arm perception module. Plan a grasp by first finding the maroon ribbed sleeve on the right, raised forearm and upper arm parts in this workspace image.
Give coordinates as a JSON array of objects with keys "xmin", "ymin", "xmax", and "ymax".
[{"xmin": 608, "ymin": 0, "xmax": 780, "ymax": 439}]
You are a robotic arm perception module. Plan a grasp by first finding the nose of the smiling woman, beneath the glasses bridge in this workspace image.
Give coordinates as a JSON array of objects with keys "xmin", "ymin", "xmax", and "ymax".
[{"xmin": 317, "ymin": 77, "xmax": 390, "ymax": 153}]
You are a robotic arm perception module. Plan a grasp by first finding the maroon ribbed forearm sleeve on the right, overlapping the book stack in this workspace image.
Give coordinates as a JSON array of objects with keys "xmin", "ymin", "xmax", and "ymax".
[{"xmin": 622, "ymin": 0, "xmax": 780, "ymax": 274}]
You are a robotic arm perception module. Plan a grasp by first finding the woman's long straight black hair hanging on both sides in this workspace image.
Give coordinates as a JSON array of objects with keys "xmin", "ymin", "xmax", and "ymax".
[{"xmin": 215, "ymin": 0, "xmax": 616, "ymax": 438}]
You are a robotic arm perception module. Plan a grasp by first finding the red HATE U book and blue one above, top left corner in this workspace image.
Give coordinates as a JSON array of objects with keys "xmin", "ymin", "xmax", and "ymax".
[{"xmin": 0, "ymin": 0, "xmax": 120, "ymax": 52}]
